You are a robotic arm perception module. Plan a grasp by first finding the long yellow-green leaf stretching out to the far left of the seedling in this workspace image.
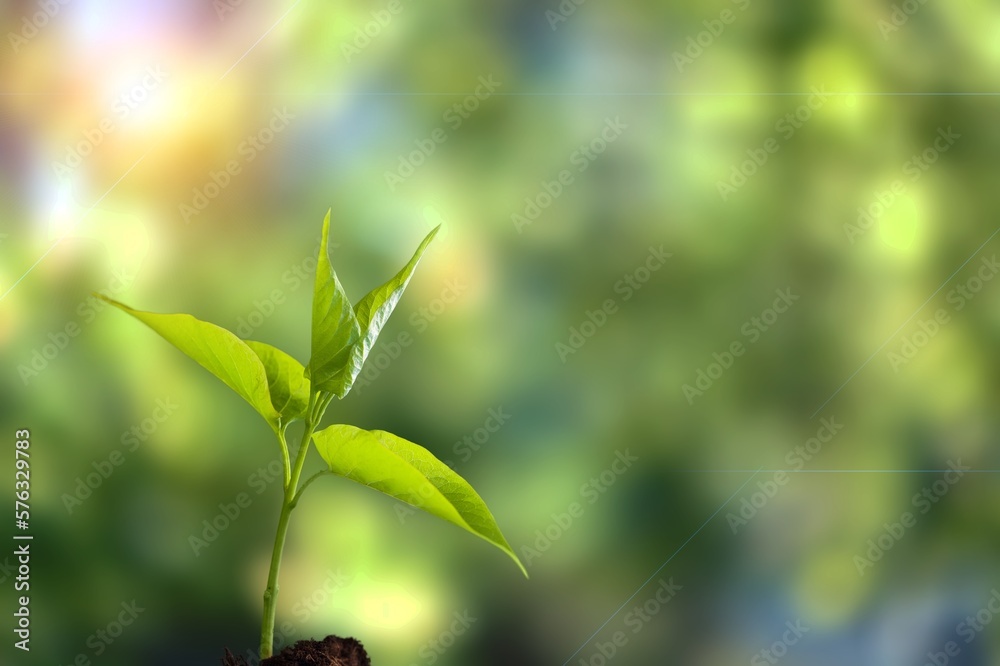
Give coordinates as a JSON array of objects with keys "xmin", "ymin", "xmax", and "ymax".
[{"xmin": 94, "ymin": 293, "xmax": 278, "ymax": 427}]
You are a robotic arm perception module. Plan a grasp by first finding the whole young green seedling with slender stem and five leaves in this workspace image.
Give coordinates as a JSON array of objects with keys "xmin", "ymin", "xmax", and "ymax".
[{"xmin": 94, "ymin": 212, "xmax": 527, "ymax": 659}]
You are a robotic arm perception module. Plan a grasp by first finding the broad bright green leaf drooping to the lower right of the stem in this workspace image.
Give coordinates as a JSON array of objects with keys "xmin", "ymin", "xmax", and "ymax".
[{"xmin": 313, "ymin": 425, "xmax": 528, "ymax": 576}]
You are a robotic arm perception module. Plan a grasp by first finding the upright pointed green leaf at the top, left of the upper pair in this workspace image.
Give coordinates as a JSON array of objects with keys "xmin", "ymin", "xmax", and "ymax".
[{"xmin": 308, "ymin": 211, "xmax": 361, "ymax": 398}]
